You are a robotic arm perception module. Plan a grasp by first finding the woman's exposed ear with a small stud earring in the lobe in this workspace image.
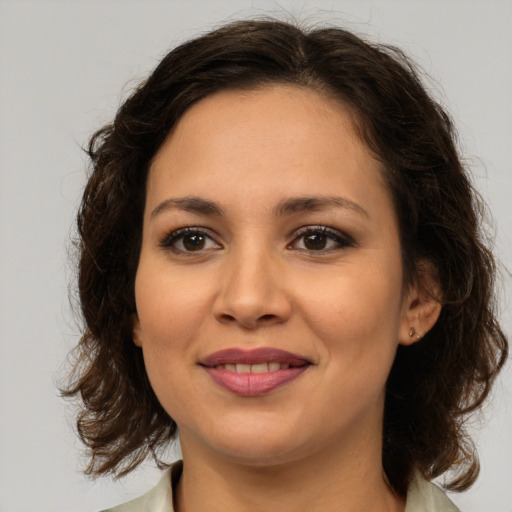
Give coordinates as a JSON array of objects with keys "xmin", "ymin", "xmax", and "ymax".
[{"xmin": 398, "ymin": 261, "xmax": 442, "ymax": 345}]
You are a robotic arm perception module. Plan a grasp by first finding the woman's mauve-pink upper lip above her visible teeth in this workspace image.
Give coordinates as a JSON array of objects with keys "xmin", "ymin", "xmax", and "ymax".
[{"xmin": 200, "ymin": 347, "xmax": 311, "ymax": 367}]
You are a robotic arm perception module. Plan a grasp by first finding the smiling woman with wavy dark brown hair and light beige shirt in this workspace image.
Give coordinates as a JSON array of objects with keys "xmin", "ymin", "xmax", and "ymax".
[{"xmin": 66, "ymin": 21, "xmax": 507, "ymax": 512}]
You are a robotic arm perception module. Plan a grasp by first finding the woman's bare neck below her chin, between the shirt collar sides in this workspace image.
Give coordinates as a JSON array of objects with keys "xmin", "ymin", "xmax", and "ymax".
[{"xmin": 175, "ymin": 428, "xmax": 405, "ymax": 512}]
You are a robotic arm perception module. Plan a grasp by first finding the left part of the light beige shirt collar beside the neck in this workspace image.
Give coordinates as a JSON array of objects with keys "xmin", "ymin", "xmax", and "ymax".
[{"xmin": 102, "ymin": 461, "xmax": 183, "ymax": 512}]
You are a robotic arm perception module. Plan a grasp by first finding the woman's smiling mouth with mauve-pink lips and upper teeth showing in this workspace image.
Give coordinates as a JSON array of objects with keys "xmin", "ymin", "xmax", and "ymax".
[{"xmin": 200, "ymin": 348, "xmax": 311, "ymax": 396}]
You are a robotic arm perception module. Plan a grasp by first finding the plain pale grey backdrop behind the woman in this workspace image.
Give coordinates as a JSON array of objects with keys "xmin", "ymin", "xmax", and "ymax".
[{"xmin": 0, "ymin": 0, "xmax": 512, "ymax": 512}]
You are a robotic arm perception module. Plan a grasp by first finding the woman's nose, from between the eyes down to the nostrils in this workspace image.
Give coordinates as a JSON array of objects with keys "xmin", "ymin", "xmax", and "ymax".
[{"xmin": 213, "ymin": 246, "xmax": 292, "ymax": 330}]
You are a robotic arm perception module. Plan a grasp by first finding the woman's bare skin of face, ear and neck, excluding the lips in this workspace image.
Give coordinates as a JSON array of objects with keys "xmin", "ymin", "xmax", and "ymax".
[{"xmin": 134, "ymin": 86, "xmax": 439, "ymax": 512}]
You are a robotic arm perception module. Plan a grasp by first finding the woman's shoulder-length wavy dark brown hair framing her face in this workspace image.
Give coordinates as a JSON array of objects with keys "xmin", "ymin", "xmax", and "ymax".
[{"xmin": 63, "ymin": 20, "xmax": 507, "ymax": 495}]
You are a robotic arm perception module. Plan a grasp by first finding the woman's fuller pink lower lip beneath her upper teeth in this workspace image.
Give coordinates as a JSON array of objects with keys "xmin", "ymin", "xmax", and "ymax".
[{"xmin": 206, "ymin": 365, "xmax": 309, "ymax": 396}]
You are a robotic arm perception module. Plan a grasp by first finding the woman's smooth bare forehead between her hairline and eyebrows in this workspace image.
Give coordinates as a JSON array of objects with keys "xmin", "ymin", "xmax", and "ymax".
[{"xmin": 148, "ymin": 85, "xmax": 385, "ymax": 216}]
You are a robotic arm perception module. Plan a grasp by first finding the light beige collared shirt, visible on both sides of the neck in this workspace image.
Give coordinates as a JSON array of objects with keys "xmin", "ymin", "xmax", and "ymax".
[{"xmin": 103, "ymin": 461, "xmax": 460, "ymax": 512}]
